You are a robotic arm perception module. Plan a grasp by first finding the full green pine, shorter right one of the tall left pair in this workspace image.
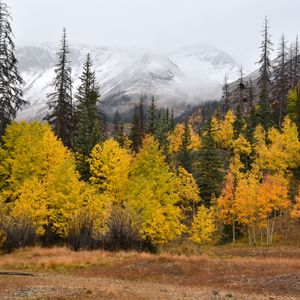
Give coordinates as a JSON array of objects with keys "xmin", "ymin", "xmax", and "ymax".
[{"xmin": 74, "ymin": 54, "xmax": 104, "ymax": 179}]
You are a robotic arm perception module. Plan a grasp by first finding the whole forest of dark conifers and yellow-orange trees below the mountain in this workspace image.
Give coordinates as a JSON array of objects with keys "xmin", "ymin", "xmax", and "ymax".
[{"xmin": 0, "ymin": 1, "xmax": 300, "ymax": 254}]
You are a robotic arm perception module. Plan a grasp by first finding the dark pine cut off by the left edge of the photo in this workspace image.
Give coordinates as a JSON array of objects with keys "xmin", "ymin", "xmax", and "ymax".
[{"xmin": 0, "ymin": 1, "xmax": 27, "ymax": 136}]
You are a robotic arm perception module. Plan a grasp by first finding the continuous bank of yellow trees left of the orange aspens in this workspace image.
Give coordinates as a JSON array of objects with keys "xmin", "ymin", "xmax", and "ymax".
[{"xmin": 0, "ymin": 122, "xmax": 213, "ymax": 245}]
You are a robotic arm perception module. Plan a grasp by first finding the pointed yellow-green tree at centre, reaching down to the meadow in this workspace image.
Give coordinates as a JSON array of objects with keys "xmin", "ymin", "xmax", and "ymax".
[{"xmin": 125, "ymin": 136, "xmax": 184, "ymax": 245}]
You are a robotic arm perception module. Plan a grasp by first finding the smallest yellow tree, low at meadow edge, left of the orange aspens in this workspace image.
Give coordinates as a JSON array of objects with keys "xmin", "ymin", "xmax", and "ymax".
[{"xmin": 189, "ymin": 205, "xmax": 216, "ymax": 244}]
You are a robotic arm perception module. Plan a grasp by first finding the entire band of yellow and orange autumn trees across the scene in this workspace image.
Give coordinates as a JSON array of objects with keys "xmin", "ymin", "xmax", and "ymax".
[{"xmin": 0, "ymin": 111, "xmax": 300, "ymax": 250}]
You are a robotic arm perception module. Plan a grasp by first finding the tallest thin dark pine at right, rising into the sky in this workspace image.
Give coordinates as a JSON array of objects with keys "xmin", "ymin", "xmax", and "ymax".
[{"xmin": 257, "ymin": 17, "xmax": 273, "ymax": 129}]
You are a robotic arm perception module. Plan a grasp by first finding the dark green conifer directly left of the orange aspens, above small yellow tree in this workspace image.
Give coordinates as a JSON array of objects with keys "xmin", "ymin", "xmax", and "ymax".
[{"xmin": 195, "ymin": 119, "xmax": 223, "ymax": 206}]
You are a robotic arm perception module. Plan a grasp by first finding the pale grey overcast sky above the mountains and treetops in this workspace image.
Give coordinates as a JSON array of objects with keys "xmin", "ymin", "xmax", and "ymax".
[{"xmin": 5, "ymin": 0, "xmax": 300, "ymax": 70}]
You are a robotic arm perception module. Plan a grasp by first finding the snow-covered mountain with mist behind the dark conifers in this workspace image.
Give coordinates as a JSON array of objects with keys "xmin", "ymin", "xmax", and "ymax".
[{"xmin": 17, "ymin": 44, "xmax": 238, "ymax": 119}]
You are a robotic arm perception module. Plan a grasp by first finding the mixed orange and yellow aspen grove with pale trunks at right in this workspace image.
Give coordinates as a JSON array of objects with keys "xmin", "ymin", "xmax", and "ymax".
[{"xmin": 212, "ymin": 111, "xmax": 300, "ymax": 245}]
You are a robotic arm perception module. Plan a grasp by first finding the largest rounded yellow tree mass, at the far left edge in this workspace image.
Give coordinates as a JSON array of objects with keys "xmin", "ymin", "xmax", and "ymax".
[{"xmin": 0, "ymin": 122, "xmax": 110, "ymax": 237}]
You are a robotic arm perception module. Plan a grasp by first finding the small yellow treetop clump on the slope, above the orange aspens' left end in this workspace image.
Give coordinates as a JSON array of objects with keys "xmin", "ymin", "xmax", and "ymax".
[{"xmin": 211, "ymin": 110, "xmax": 235, "ymax": 150}]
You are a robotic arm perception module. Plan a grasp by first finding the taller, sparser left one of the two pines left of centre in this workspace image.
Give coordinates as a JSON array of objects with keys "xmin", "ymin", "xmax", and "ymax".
[{"xmin": 46, "ymin": 28, "xmax": 73, "ymax": 147}]
